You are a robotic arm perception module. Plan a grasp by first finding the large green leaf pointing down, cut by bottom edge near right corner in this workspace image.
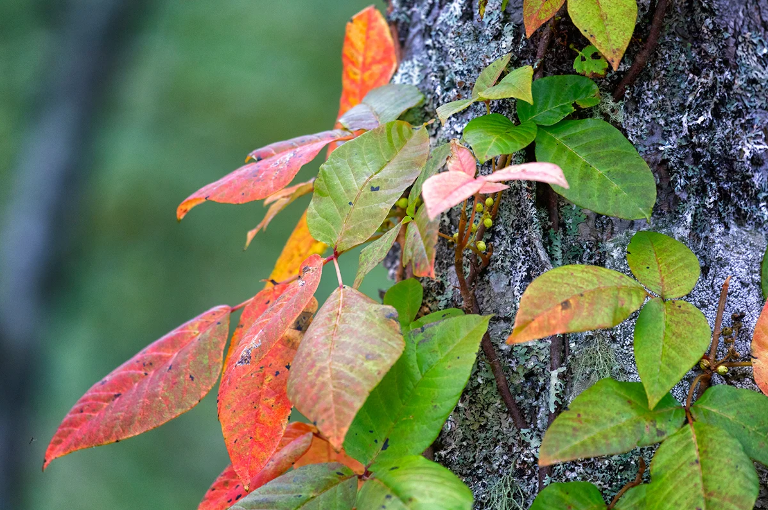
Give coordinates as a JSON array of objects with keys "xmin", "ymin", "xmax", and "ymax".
[{"xmin": 646, "ymin": 422, "xmax": 760, "ymax": 510}]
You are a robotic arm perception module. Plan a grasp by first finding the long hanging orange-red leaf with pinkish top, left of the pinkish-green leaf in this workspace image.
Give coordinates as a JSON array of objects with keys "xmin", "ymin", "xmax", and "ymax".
[{"xmin": 218, "ymin": 255, "xmax": 323, "ymax": 489}]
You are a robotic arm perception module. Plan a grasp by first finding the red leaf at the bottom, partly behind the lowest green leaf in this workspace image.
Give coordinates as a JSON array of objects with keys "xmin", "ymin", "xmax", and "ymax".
[{"xmin": 197, "ymin": 423, "xmax": 313, "ymax": 510}]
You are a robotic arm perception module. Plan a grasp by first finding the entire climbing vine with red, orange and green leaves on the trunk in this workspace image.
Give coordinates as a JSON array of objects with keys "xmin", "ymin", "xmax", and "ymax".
[{"xmin": 43, "ymin": 0, "xmax": 768, "ymax": 510}]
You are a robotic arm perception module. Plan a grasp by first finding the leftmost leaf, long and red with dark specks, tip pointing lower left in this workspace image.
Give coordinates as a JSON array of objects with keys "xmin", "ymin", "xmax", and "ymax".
[{"xmin": 43, "ymin": 305, "xmax": 230, "ymax": 469}]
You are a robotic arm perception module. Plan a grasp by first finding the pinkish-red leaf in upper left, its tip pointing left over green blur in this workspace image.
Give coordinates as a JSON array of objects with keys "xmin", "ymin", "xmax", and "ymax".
[{"xmin": 176, "ymin": 129, "xmax": 354, "ymax": 221}]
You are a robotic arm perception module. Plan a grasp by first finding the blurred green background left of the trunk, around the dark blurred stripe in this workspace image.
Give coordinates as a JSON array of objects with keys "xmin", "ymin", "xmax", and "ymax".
[{"xmin": 0, "ymin": 0, "xmax": 389, "ymax": 510}]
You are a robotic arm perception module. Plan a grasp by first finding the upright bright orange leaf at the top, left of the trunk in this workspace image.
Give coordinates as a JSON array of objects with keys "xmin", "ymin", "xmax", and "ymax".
[{"xmin": 338, "ymin": 6, "xmax": 397, "ymax": 117}]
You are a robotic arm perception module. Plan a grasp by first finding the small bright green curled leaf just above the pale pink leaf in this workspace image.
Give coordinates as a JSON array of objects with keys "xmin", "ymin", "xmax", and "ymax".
[{"xmin": 464, "ymin": 113, "xmax": 536, "ymax": 163}]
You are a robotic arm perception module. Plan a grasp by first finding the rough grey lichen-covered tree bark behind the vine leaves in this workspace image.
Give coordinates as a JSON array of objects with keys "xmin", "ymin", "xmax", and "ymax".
[{"xmin": 390, "ymin": 0, "xmax": 768, "ymax": 509}]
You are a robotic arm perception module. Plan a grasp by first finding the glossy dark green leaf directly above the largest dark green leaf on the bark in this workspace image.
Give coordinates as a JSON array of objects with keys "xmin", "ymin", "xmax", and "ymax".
[{"xmin": 517, "ymin": 75, "xmax": 600, "ymax": 126}]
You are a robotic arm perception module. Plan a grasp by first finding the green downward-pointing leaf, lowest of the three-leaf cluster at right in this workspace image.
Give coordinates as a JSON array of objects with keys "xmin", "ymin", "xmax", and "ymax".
[{"xmin": 635, "ymin": 298, "xmax": 712, "ymax": 408}]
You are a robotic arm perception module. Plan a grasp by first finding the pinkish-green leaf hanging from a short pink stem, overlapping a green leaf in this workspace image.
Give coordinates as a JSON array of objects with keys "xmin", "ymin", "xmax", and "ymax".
[{"xmin": 288, "ymin": 286, "xmax": 405, "ymax": 451}]
